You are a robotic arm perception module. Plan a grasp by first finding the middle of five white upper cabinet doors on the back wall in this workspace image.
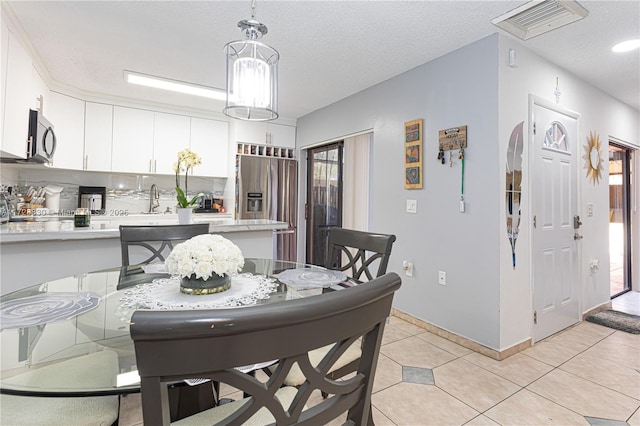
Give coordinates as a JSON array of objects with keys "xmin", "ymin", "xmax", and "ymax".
[{"xmin": 111, "ymin": 106, "xmax": 154, "ymax": 173}]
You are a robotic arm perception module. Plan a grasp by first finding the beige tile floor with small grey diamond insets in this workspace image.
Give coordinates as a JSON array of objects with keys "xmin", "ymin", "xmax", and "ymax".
[{"xmin": 120, "ymin": 295, "xmax": 640, "ymax": 426}]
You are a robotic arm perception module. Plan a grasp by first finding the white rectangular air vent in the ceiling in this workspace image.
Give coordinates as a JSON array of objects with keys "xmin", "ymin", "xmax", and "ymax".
[{"xmin": 491, "ymin": 0, "xmax": 589, "ymax": 40}]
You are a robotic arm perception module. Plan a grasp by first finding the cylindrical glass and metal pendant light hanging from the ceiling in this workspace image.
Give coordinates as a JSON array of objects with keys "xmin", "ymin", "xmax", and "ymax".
[{"xmin": 223, "ymin": 0, "xmax": 280, "ymax": 121}]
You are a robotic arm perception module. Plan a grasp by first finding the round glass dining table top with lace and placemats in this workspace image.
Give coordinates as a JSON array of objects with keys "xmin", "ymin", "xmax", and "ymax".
[{"xmin": 0, "ymin": 258, "xmax": 346, "ymax": 397}]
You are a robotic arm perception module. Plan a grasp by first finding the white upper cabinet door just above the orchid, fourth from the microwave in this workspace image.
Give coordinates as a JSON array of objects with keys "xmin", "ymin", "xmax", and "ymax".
[{"xmin": 153, "ymin": 112, "xmax": 190, "ymax": 174}]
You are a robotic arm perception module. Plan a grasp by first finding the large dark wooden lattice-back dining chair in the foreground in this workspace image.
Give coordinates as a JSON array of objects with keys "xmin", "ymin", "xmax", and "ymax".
[{"xmin": 130, "ymin": 273, "xmax": 401, "ymax": 425}]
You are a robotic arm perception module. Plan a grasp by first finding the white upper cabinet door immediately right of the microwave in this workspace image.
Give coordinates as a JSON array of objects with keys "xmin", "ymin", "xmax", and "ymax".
[{"xmin": 47, "ymin": 92, "xmax": 84, "ymax": 170}]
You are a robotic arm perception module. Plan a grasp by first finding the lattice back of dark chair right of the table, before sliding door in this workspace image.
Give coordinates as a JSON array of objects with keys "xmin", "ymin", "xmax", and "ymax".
[{"xmin": 325, "ymin": 228, "xmax": 396, "ymax": 281}]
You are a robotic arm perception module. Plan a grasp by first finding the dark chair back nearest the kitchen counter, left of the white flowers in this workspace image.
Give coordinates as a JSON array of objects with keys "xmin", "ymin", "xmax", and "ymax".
[{"xmin": 120, "ymin": 223, "xmax": 209, "ymax": 266}]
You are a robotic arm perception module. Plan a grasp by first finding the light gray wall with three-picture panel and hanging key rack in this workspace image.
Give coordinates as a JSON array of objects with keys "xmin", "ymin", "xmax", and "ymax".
[{"xmin": 296, "ymin": 35, "xmax": 504, "ymax": 348}]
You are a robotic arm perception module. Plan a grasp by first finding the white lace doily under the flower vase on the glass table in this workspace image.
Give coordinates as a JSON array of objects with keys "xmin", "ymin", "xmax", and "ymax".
[{"xmin": 117, "ymin": 273, "xmax": 278, "ymax": 321}]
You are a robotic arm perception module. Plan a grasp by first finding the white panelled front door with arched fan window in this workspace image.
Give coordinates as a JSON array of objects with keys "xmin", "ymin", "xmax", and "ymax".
[{"xmin": 529, "ymin": 96, "xmax": 580, "ymax": 342}]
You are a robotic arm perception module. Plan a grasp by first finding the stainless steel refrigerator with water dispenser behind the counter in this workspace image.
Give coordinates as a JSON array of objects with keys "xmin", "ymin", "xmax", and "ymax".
[{"xmin": 236, "ymin": 155, "xmax": 298, "ymax": 261}]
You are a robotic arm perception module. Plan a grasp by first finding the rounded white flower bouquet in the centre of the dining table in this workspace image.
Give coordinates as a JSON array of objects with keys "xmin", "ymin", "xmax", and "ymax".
[{"xmin": 164, "ymin": 234, "xmax": 244, "ymax": 280}]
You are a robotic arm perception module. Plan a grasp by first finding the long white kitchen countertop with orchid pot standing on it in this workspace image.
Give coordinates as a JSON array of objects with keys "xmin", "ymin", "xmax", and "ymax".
[{"xmin": 0, "ymin": 214, "xmax": 288, "ymax": 244}]
